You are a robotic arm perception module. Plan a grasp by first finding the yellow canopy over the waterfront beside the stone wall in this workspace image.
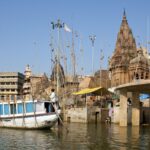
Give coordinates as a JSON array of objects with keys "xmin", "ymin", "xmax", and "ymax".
[{"xmin": 72, "ymin": 87, "xmax": 110, "ymax": 96}]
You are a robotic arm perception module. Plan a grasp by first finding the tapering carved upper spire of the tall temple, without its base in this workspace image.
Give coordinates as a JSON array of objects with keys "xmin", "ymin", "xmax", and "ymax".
[{"xmin": 112, "ymin": 10, "xmax": 137, "ymax": 66}]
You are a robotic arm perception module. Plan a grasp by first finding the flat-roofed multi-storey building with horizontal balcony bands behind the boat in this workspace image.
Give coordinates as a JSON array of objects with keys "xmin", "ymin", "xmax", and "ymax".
[{"xmin": 0, "ymin": 72, "xmax": 24, "ymax": 101}]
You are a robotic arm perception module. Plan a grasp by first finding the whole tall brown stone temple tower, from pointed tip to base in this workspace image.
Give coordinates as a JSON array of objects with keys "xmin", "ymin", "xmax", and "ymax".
[{"xmin": 109, "ymin": 11, "xmax": 137, "ymax": 87}]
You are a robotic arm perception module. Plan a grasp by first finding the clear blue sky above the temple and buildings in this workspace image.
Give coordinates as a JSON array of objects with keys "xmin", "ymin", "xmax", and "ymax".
[{"xmin": 0, "ymin": 0, "xmax": 150, "ymax": 74}]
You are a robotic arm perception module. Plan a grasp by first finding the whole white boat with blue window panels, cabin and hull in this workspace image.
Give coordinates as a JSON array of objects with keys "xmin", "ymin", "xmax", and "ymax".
[{"xmin": 0, "ymin": 100, "xmax": 60, "ymax": 129}]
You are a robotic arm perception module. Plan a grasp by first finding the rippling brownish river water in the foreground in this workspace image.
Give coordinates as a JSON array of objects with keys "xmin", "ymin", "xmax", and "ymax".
[{"xmin": 0, "ymin": 123, "xmax": 150, "ymax": 150}]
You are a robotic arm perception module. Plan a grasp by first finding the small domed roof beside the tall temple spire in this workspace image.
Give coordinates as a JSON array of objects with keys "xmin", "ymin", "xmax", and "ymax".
[{"xmin": 130, "ymin": 47, "xmax": 149, "ymax": 65}]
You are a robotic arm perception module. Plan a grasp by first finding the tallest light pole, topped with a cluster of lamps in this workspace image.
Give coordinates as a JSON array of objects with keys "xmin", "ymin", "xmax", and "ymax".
[{"xmin": 51, "ymin": 19, "xmax": 64, "ymax": 95}]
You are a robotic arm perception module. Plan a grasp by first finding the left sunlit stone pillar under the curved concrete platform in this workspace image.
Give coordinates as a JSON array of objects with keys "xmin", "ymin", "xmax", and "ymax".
[{"xmin": 120, "ymin": 90, "xmax": 128, "ymax": 126}]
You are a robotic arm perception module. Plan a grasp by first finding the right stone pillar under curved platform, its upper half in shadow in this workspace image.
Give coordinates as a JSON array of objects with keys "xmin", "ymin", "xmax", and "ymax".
[{"xmin": 132, "ymin": 92, "xmax": 140, "ymax": 126}]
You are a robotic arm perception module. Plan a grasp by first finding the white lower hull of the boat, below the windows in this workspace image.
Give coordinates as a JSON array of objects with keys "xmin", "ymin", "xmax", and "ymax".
[{"xmin": 0, "ymin": 113, "xmax": 58, "ymax": 129}]
